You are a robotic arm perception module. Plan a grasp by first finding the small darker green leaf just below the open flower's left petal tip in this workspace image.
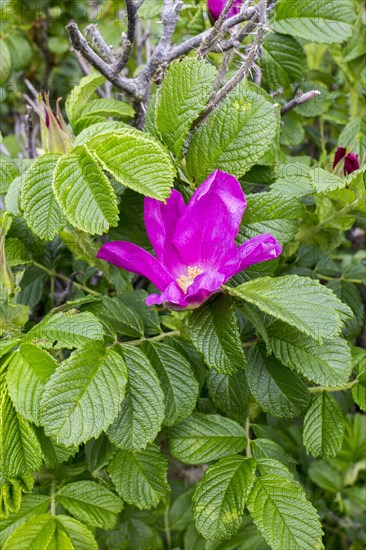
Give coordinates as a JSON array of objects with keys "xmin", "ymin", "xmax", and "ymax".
[{"xmin": 87, "ymin": 296, "xmax": 144, "ymax": 338}]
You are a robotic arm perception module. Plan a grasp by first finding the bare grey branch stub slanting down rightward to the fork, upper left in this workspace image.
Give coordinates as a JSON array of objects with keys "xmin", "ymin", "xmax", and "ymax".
[{"xmin": 66, "ymin": 23, "xmax": 142, "ymax": 98}]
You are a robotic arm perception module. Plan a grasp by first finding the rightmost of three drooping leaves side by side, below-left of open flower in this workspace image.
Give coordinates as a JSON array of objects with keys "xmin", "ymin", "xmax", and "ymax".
[{"xmin": 142, "ymin": 342, "xmax": 199, "ymax": 426}]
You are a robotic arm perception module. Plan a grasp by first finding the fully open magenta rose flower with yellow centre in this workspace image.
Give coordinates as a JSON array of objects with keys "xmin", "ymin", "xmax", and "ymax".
[{"xmin": 98, "ymin": 170, "xmax": 282, "ymax": 308}]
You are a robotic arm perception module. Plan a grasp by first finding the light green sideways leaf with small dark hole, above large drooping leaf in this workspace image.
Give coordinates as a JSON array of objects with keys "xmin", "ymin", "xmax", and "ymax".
[{"xmin": 26, "ymin": 309, "xmax": 103, "ymax": 349}]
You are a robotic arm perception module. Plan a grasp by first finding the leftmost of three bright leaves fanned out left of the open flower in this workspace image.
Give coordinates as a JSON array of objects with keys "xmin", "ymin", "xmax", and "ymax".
[{"xmin": 21, "ymin": 153, "xmax": 66, "ymax": 241}]
